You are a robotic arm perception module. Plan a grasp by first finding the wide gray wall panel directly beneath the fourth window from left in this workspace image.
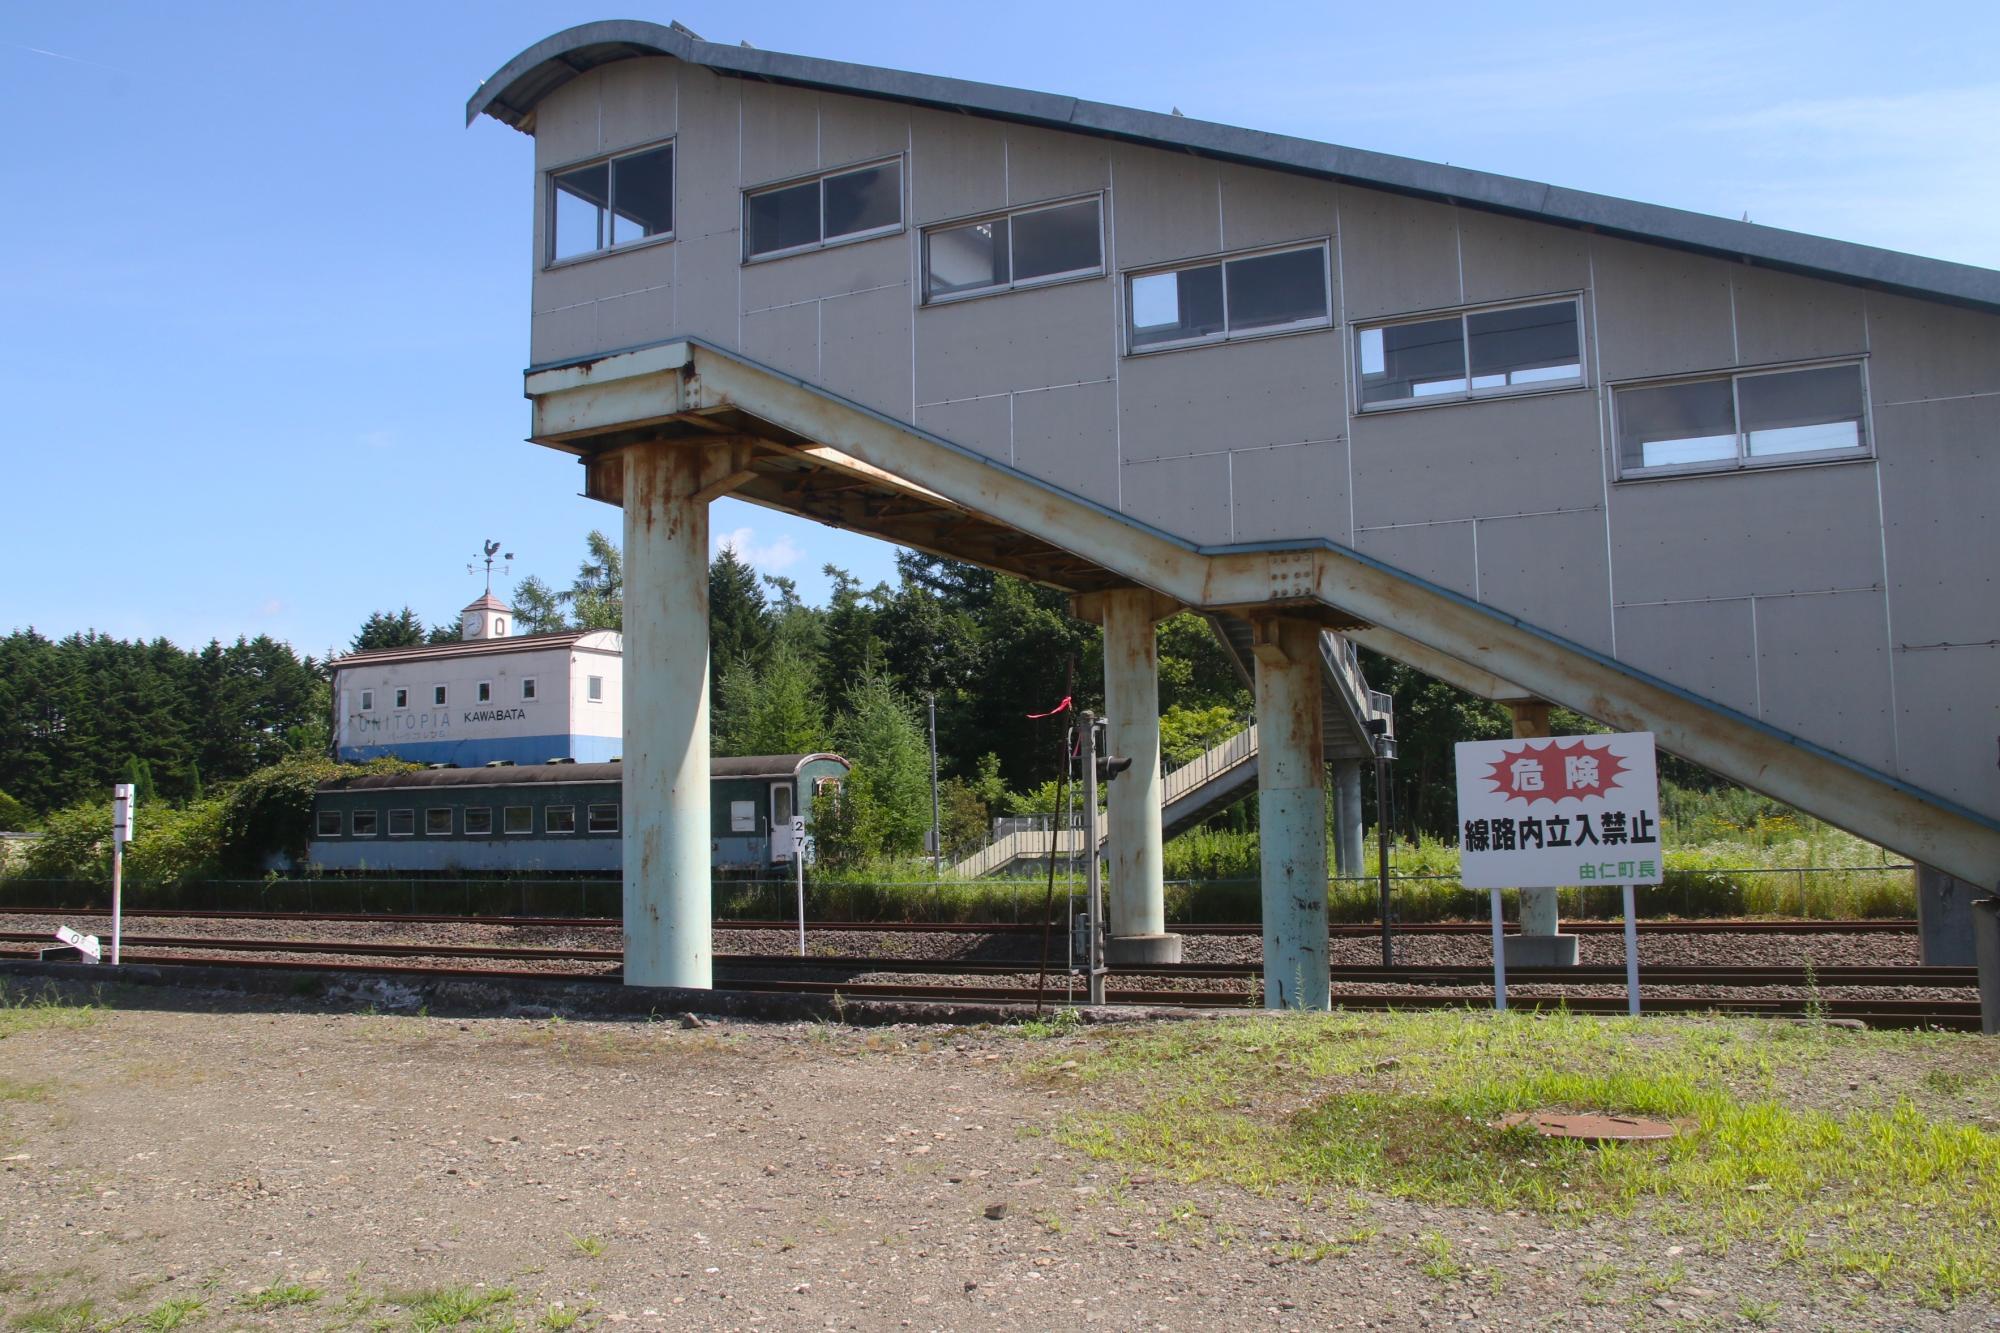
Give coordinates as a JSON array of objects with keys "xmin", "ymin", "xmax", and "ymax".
[{"xmin": 1118, "ymin": 330, "xmax": 1346, "ymax": 462}]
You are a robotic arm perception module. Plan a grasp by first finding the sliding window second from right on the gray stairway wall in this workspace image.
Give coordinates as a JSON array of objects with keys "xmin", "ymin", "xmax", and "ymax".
[{"xmin": 1354, "ymin": 296, "xmax": 1584, "ymax": 408}]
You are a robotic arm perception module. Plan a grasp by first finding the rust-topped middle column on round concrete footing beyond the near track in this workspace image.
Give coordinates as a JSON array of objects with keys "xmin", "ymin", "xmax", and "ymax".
[{"xmin": 1100, "ymin": 588, "xmax": 1180, "ymax": 967}]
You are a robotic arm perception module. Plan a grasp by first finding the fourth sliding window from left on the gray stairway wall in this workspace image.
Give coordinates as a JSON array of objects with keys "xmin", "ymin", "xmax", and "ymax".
[{"xmin": 1126, "ymin": 242, "xmax": 1332, "ymax": 352}]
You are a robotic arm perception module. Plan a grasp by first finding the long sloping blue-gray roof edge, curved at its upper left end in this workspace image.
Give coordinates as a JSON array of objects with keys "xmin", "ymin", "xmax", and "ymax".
[{"xmin": 466, "ymin": 20, "xmax": 2000, "ymax": 312}]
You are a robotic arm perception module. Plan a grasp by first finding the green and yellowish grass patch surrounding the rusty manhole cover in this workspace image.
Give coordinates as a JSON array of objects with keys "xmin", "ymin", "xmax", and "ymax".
[{"xmin": 1036, "ymin": 1011, "xmax": 2000, "ymax": 1309}]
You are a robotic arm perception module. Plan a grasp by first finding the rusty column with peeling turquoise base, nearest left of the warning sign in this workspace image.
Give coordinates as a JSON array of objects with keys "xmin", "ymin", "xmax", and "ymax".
[{"xmin": 1254, "ymin": 616, "xmax": 1332, "ymax": 1009}]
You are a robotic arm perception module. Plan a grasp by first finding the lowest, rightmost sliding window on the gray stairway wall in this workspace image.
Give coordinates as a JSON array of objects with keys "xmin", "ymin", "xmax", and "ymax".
[{"xmin": 1612, "ymin": 362, "xmax": 1868, "ymax": 476}]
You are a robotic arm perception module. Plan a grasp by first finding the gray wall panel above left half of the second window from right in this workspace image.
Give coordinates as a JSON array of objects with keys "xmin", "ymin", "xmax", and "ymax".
[{"xmin": 1340, "ymin": 188, "xmax": 1462, "ymax": 320}]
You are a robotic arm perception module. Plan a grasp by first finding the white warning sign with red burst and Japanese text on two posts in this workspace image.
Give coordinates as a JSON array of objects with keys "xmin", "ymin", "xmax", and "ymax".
[{"xmin": 1456, "ymin": 731, "xmax": 1666, "ymax": 1013}]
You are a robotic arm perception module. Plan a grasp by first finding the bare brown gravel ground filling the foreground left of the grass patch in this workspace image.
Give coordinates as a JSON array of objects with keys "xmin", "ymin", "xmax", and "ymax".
[{"xmin": 0, "ymin": 1009, "xmax": 1994, "ymax": 1329}]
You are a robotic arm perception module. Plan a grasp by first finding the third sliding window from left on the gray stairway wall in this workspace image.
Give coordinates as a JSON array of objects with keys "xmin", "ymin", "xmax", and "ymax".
[{"xmin": 924, "ymin": 198, "xmax": 1104, "ymax": 300}]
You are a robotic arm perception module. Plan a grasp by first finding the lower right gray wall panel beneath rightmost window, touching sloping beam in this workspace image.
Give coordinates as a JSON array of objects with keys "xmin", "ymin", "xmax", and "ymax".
[{"xmin": 1756, "ymin": 592, "xmax": 1896, "ymax": 773}]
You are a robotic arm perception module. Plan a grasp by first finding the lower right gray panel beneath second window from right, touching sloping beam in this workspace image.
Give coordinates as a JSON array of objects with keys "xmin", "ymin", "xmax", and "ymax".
[{"xmin": 1476, "ymin": 510, "xmax": 1612, "ymax": 652}]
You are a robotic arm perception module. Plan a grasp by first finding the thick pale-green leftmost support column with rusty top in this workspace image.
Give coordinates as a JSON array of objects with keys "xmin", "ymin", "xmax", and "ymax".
[{"xmin": 622, "ymin": 442, "xmax": 714, "ymax": 989}]
